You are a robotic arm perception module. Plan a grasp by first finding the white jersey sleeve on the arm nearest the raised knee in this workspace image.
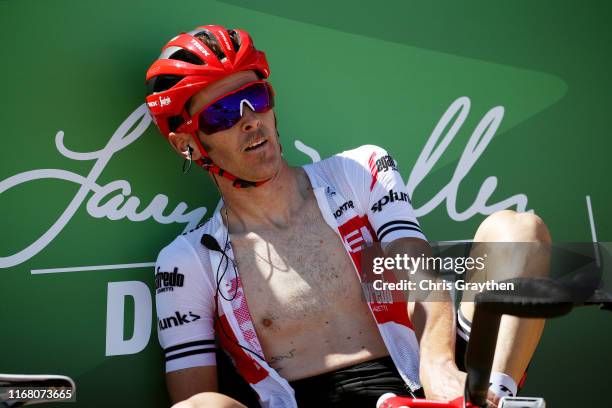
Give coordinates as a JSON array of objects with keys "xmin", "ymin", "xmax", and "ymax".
[{"xmin": 345, "ymin": 145, "xmax": 427, "ymax": 244}]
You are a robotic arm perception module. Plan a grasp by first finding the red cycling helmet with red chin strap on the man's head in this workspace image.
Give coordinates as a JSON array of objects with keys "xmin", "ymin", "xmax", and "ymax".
[{"xmin": 146, "ymin": 25, "xmax": 270, "ymax": 187}]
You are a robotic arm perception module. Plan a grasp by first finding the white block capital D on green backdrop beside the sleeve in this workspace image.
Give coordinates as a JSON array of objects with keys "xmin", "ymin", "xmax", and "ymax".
[{"xmin": 106, "ymin": 281, "xmax": 152, "ymax": 356}]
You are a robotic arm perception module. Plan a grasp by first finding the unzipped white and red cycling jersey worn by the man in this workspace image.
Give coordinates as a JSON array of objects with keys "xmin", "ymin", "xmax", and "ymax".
[{"xmin": 155, "ymin": 145, "xmax": 425, "ymax": 408}]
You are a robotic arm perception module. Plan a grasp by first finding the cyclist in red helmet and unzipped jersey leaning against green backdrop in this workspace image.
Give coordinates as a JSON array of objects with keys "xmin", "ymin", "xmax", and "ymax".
[{"xmin": 147, "ymin": 25, "xmax": 550, "ymax": 407}]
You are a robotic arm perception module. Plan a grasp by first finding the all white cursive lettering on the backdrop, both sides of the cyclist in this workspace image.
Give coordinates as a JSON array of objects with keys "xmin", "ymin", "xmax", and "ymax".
[{"xmin": 0, "ymin": 96, "xmax": 527, "ymax": 268}]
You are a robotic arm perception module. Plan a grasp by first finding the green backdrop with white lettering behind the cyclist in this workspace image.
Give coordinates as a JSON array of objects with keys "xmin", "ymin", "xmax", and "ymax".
[{"xmin": 0, "ymin": 0, "xmax": 612, "ymax": 407}]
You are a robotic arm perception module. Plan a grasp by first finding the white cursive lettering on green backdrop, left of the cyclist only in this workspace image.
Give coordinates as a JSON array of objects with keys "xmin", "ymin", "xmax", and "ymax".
[{"xmin": 0, "ymin": 104, "xmax": 206, "ymax": 268}]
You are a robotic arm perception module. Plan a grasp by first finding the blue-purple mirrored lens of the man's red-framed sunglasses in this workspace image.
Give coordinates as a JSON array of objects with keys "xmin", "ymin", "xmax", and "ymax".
[{"xmin": 198, "ymin": 82, "xmax": 274, "ymax": 134}]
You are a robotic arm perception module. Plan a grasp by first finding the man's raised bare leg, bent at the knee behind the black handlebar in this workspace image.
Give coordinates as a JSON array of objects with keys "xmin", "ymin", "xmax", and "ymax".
[{"xmin": 460, "ymin": 210, "xmax": 551, "ymax": 385}]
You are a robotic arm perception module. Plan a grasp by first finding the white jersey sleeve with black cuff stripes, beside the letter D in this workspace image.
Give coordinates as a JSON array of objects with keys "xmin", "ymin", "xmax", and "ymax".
[{"xmin": 155, "ymin": 237, "xmax": 216, "ymax": 372}]
